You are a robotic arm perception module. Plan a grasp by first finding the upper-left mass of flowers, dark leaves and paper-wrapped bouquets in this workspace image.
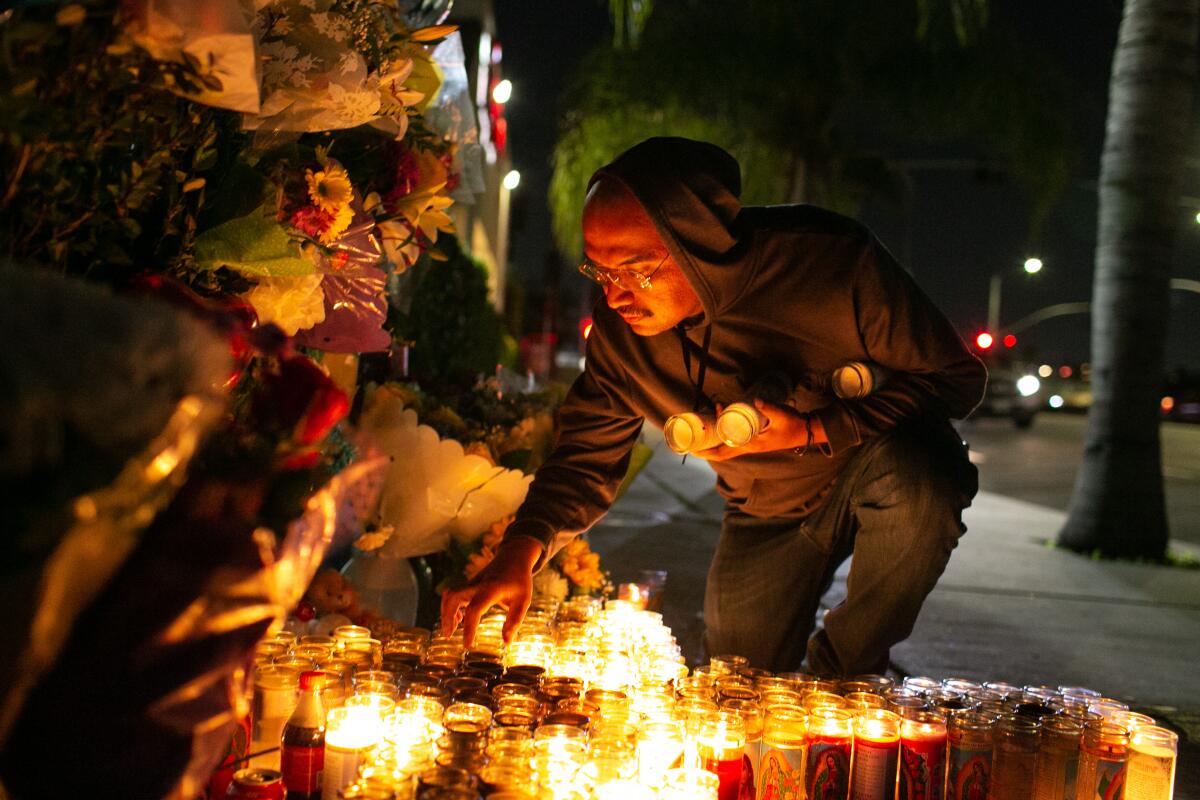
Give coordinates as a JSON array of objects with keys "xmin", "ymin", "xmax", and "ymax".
[{"xmin": 0, "ymin": 0, "xmax": 456, "ymax": 351}]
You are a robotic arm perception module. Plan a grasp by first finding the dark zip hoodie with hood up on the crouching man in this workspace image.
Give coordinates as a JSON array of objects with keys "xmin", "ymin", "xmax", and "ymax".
[{"xmin": 506, "ymin": 138, "xmax": 986, "ymax": 560}]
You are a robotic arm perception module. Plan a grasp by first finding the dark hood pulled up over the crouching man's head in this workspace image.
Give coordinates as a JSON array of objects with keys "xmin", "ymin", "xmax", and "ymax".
[{"xmin": 588, "ymin": 137, "xmax": 744, "ymax": 320}]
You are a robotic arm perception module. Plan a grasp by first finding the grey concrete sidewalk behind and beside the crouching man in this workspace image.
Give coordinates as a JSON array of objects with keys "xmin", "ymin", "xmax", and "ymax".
[{"xmin": 592, "ymin": 429, "xmax": 1200, "ymax": 798}]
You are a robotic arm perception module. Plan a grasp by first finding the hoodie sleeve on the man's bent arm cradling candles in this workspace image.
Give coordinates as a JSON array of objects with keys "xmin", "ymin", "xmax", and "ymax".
[{"xmin": 816, "ymin": 237, "xmax": 988, "ymax": 453}]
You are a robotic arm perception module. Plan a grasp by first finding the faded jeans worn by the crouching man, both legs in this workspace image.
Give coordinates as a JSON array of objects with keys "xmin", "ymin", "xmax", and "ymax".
[{"xmin": 704, "ymin": 425, "xmax": 978, "ymax": 676}]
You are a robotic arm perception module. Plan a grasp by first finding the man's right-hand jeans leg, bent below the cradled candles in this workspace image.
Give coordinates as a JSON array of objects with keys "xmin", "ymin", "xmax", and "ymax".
[{"xmin": 804, "ymin": 427, "xmax": 978, "ymax": 675}]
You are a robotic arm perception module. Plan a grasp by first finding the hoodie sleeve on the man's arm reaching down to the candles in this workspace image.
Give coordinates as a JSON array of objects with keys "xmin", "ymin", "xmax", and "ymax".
[{"xmin": 505, "ymin": 331, "xmax": 643, "ymax": 569}]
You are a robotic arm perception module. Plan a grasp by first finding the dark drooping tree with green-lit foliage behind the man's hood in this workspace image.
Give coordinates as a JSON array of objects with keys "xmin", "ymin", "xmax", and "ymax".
[{"xmin": 550, "ymin": 0, "xmax": 1069, "ymax": 258}]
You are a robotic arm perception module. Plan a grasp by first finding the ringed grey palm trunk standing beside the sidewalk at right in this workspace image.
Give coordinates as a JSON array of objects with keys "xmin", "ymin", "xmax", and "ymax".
[{"xmin": 1058, "ymin": 0, "xmax": 1200, "ymax": 559}]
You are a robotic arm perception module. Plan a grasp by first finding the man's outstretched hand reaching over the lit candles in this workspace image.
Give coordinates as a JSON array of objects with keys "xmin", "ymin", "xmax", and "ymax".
[{"xmin": 442, "ymin": 536, "xmax": 542, "ymax": 649}]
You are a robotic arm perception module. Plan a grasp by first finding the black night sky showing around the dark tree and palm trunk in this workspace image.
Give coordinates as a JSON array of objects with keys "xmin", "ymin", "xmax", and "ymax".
[{"xmin": 496, "ymin": 0, "xmax": 1200, "ymax": 369}]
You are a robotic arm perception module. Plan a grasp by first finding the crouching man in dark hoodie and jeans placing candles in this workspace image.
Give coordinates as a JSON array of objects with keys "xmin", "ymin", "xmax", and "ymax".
[{"xmin": 442, "ymin": 138, "xmax": 986, "ymax": 676}]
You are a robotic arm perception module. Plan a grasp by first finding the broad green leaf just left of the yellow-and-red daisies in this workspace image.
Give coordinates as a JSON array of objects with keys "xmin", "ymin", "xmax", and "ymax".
[{"xmin": 196, "ymin": 206, "xmax": 316, "ymax": 277}]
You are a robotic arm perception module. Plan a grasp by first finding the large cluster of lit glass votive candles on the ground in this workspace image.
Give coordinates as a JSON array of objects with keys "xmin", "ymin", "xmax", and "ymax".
[{"xmin": 253, "ymin": 599, "xmax": 1177, "ymax": 800}]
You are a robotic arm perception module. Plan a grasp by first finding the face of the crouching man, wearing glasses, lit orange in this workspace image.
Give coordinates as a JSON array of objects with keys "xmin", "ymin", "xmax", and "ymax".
[{"xmin": 583, "ymin": 180, "xmax": 703, "ymax": 336}]
